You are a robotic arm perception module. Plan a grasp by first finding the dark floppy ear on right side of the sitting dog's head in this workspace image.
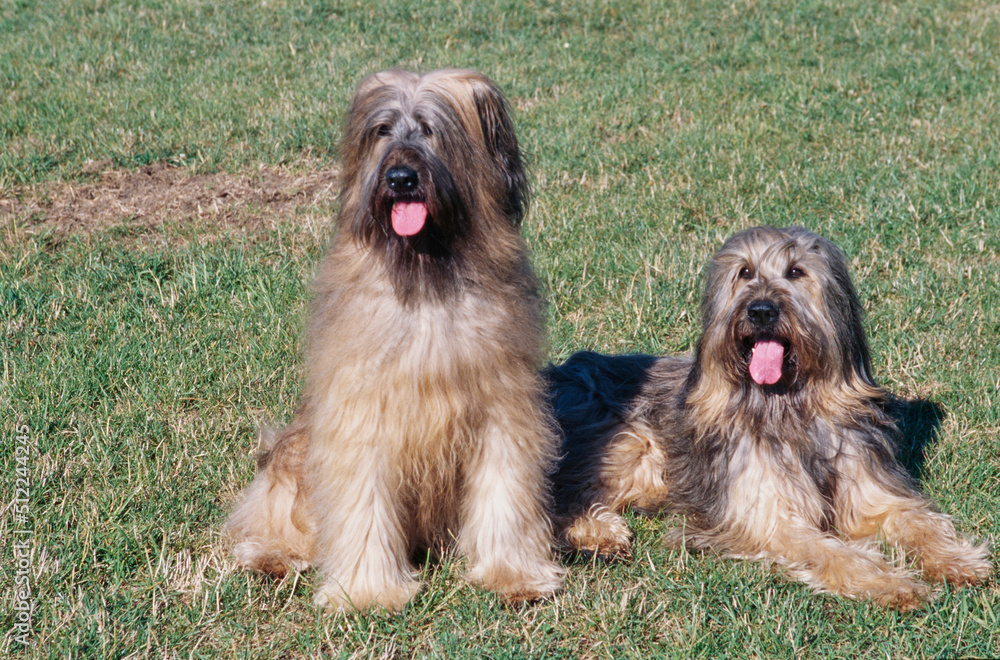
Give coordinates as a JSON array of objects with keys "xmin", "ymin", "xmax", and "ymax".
[{"xmin": 473, "ymin": 77, "xmax": 528, "ymax": 225}]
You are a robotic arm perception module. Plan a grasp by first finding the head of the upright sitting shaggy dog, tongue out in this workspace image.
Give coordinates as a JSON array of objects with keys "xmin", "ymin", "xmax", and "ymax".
[{"xmin": 342, "ymin": 70, "xmax": 528, "ymax": 251}]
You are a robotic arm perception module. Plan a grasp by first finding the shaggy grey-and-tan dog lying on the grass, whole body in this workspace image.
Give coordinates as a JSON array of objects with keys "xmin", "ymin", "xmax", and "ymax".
[{"xmin": 548, "ymin": 227, "xmax": 991, "ymax": 610}]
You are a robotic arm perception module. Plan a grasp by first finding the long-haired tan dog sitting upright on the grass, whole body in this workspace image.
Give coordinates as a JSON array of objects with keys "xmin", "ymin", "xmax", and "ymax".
[{"xmin": 228, "ymin": 70, "xmax": 563, "ymax": 610}]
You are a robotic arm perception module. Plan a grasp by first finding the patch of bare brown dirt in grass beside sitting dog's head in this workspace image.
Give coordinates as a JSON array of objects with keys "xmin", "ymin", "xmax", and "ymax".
[{"xmin": 0, "ymin": 162, "xmax": 337, "ymax": 245}]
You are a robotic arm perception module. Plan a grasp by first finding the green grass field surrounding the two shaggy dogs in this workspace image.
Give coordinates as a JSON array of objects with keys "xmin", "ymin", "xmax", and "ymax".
[{"xmin": 0, "ymin": 0, "xmax": 1000, "ymax": 658}]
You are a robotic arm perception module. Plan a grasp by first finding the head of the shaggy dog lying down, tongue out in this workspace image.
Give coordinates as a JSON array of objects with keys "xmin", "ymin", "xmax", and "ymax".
[{"xmin": 698, "ymin": 227, "xmax": 875, "ymax": 392}]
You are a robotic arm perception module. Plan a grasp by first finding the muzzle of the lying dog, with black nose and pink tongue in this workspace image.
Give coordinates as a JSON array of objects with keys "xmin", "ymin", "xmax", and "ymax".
[{"xmin": 737, "ymin": 298, "xmax": 796, "ymax": 388}]
